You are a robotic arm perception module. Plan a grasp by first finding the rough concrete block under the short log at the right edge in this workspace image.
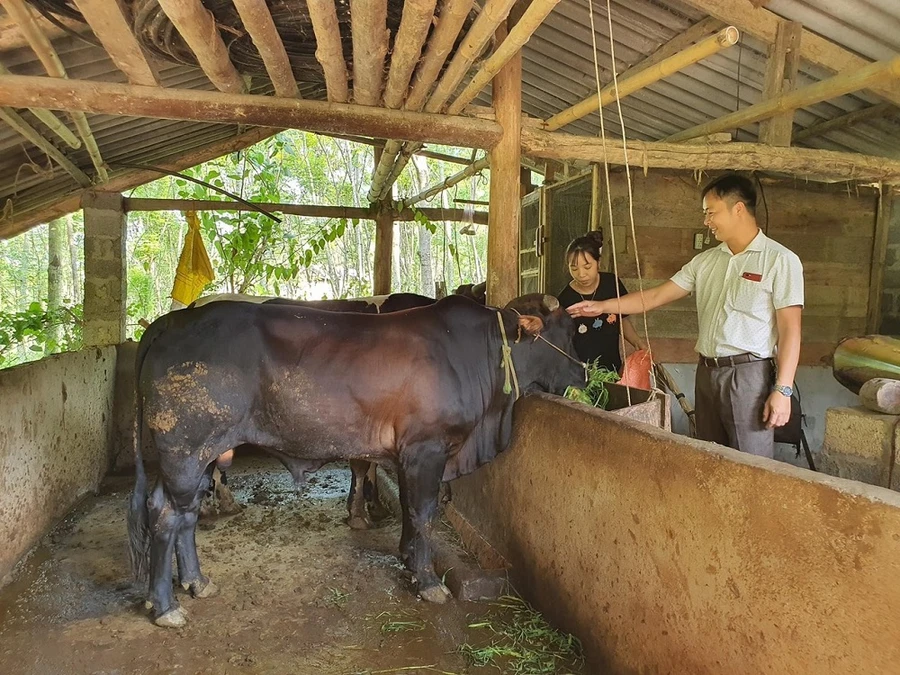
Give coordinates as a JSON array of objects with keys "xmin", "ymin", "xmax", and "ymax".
[{"xmin": 822, "ymin": 406, "xmax": 900, "ymax": 487}]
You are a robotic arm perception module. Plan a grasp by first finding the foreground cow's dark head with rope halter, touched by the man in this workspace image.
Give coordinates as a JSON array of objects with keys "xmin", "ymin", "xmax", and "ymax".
[{"xmin": 506, "ymin": 293, "xmax": 585, "ymax": 395}]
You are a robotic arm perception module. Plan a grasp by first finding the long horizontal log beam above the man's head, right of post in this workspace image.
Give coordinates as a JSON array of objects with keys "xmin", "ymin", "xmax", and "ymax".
[{"xmin": 522, "ymin": 128, "xmax": 900, "ymax": 185}]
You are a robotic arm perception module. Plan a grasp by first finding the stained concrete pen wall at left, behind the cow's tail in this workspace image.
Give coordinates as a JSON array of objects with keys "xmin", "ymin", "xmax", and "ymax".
[{"xmin": 0, "ymin": 347, "xmax": 116, "ymax": 585}]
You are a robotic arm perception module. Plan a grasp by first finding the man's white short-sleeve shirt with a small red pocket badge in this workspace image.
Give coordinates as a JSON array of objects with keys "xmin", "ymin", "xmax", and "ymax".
[{"xmin": 672, "ymin": 230, "xmax": 803, "ymax": 358}]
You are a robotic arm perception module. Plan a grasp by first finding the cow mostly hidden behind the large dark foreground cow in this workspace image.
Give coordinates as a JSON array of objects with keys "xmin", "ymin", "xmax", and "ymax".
[{"xmin": 188, "ymin": 287, "xmax": 442, "ymax": 530}]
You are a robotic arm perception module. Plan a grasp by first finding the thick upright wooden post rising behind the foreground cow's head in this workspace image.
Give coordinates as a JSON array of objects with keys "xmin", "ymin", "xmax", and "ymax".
[{"xmin": 487, "ymin": 27, "xmax": 522, "ymax": 307}]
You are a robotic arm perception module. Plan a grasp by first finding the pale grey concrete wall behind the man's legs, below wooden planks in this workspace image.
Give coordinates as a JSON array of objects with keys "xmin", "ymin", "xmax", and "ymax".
[{"xmin": 663, "ymin": 363, "xmax": 859, "ymax": 467}]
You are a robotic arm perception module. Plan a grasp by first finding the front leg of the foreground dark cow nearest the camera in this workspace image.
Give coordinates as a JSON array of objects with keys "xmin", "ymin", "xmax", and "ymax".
[{"xmin": 400, "ymin": 443, "xmax": 450, "ymax": 603}]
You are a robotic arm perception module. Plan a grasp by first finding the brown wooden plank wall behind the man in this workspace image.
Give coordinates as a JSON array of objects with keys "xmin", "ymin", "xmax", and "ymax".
[{"xmin": 602, "ymin": 171, "xmax": 877, "ymax": 365}]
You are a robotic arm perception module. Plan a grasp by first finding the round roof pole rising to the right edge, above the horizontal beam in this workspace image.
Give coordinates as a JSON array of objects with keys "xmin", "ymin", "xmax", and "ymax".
[{"xmin": 666, "ymin": 56, "xmax": 900, "ymax": 141}]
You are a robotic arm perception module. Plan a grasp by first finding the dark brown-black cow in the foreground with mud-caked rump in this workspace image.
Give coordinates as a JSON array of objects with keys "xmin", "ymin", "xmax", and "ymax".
[{"xmin": 128, "ymin": 295, "xmax": 585, "ymax": 626}]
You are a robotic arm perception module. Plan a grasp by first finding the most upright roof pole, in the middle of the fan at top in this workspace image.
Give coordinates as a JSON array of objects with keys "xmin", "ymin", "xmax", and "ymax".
[{"xmin": 350, "ymin": 0, "xmax": 390, "ymax": 105}]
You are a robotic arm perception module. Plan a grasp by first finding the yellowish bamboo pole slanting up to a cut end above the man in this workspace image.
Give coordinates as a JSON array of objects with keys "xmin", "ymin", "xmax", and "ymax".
[{"xmin": 544, "ymin": 26, "xmax": 740, "ymax": 131}]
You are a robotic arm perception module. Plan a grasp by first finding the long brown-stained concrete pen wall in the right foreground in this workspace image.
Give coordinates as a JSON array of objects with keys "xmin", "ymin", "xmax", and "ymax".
[{"xmin": 453, "ymin": 396, "xmax": 900, "ymax": 675}]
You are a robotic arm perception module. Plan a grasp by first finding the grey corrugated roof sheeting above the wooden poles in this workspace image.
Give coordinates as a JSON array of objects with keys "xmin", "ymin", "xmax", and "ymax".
[{"xmin": 0, "ymin": 0, "xmax": 900, "ymax": 236}]
